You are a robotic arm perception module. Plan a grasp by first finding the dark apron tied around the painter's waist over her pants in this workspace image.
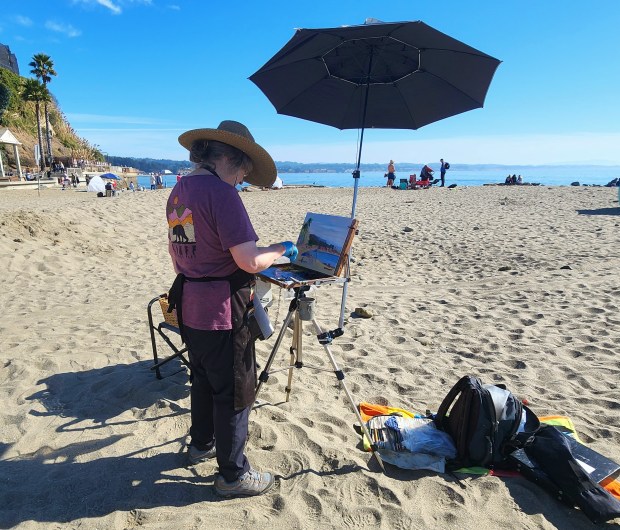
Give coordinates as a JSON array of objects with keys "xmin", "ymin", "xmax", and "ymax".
[{"xmin": 168, "ymin": 269, "xmax": 256, "ymax": 410}]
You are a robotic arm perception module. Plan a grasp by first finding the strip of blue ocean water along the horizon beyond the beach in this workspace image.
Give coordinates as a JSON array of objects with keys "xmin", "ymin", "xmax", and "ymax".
[{"xmin": 138, "ymin": 165, "xmax": 620, "ymax": 189}]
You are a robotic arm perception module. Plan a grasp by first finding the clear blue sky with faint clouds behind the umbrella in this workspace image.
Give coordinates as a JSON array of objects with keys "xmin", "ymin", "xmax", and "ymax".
[{"xmin": 0, "ymin": 0, "xmax": 620, "ymax": 164}]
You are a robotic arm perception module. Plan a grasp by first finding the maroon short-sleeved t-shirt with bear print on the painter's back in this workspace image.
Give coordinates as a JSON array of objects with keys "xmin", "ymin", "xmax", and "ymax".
[{"xmin": 166, "ymin": 169, "xmax": 258, "ymax": 330}]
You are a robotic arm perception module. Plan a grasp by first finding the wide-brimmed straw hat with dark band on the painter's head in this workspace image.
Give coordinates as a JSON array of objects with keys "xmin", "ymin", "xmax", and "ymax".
[{"xmin": 179, "ymin": 120, "xmax": 277, "ymax": 187}]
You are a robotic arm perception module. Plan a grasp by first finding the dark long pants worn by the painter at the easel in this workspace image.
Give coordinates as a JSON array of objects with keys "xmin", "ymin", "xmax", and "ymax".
[{"xmin": 185, "ymin": 326, "xmax": 251, "ymax": 482}]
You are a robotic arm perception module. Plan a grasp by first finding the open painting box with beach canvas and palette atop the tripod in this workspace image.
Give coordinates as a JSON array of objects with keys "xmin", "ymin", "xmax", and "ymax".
[{"xmin": 258, "ymin": 212, "xmax": 358, "ymax": 289}]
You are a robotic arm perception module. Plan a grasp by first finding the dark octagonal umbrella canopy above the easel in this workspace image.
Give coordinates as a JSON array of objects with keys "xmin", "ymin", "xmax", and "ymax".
[{"xmin": 250, "ymin": 21, "xmax": 500, "ymax": 129}]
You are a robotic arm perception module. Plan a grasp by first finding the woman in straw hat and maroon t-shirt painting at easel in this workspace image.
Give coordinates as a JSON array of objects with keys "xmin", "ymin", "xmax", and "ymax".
[{"xmin": 166, "ymin": 121, "xmax": 297, "ymax": 497}]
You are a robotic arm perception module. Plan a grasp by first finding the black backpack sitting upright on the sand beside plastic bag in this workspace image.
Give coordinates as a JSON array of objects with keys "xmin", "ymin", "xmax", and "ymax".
[{"xmin": 435, "ymin": 375, "xmax": 540, "ymax": 469}]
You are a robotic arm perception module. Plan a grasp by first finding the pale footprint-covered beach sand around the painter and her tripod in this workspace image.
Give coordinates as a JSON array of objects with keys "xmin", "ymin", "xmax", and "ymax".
[{"xmin": 0, "ymin": 186, "xmax": 620, "ymax": 530}]
